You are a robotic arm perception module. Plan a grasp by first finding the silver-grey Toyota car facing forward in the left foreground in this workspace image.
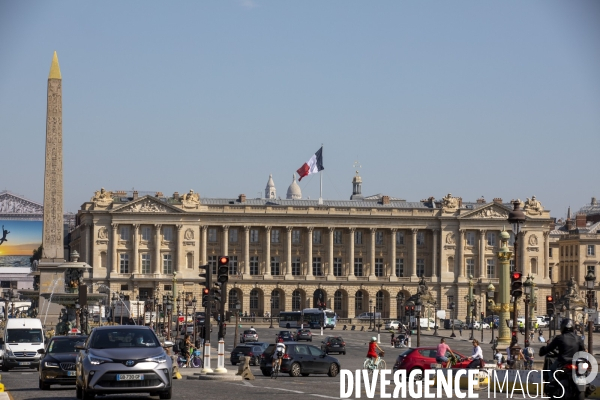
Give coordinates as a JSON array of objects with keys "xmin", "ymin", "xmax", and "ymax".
[{"xmin": 76, "ymin": 325, "xmax": 173, "ymax": 400}]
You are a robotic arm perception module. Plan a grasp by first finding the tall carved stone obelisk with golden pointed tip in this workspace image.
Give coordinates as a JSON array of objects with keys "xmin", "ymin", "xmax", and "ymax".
[{"xmin": 42, "ymin": 52, "xmax": 64, "ymax": 261}]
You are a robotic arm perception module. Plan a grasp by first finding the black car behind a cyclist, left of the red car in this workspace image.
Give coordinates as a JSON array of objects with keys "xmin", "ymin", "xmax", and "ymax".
[{"xmin": 260, "ymin": 342, "xmax": 340, "ymax": 377}]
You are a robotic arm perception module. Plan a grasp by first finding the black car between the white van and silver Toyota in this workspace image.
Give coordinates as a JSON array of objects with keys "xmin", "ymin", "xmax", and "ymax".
[{"xmin": 38, "ymin": 335, "xmax": 87, "ymax": 390}]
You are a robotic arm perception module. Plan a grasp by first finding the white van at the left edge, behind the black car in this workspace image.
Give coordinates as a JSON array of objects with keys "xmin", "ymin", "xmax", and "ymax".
[{"xmin": 2, "ymin": 318, "xmax": 44, "ymax": 371}]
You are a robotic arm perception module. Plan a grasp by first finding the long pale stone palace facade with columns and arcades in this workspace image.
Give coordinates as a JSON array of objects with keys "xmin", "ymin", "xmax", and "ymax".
[{"xmin": 71, "ymin": 185, "xmax": 552, "ymax": 319}]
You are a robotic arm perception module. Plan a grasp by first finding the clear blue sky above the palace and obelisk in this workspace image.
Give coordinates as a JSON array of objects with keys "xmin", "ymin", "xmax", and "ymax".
[{"xmin": 0, "ymin": 0, "xmax": 600, "ymax": 217}]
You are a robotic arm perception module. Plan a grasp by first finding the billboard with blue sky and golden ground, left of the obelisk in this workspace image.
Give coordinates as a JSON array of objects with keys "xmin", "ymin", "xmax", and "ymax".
[{"xmin": 0, "ymin": 219, "xmax": 43, "ymax": 267}]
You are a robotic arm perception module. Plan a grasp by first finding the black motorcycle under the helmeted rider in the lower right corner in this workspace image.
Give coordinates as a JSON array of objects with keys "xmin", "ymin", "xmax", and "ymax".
[{"xmin": 539, "ymin": 346, "xmax": 596, "ymax": 400}]
